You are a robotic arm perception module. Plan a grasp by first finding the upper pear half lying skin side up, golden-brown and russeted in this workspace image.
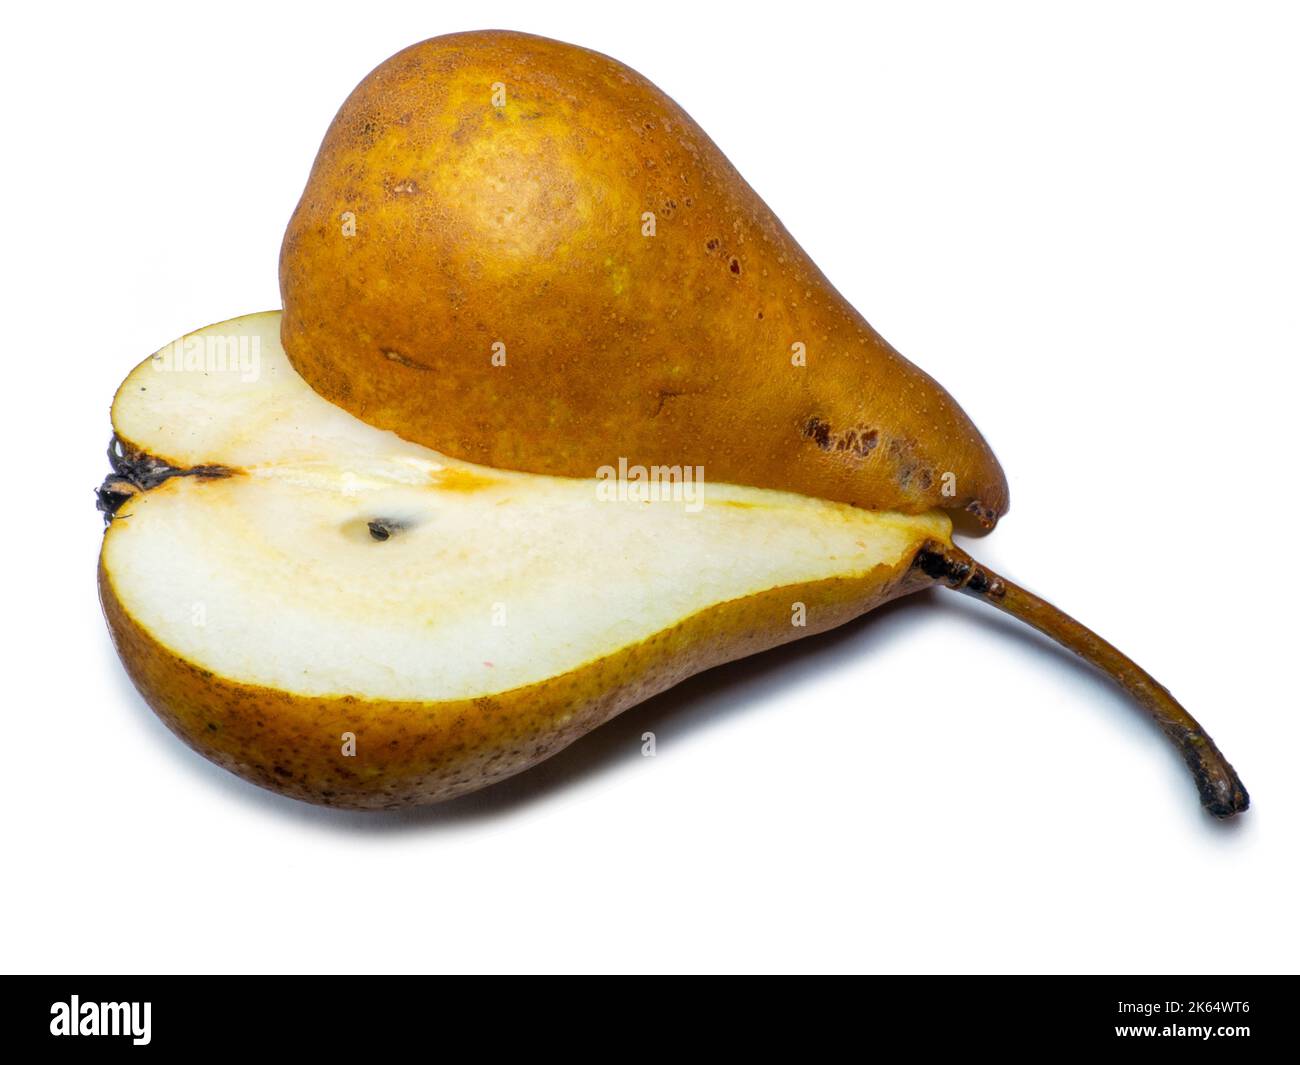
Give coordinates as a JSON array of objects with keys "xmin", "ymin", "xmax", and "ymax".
[{"xmin": 280, "ymin": 31, "xmax": 1008, "ymax": 525}]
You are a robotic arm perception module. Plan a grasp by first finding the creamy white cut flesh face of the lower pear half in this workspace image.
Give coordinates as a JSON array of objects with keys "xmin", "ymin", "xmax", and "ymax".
[{"xmin": 104, "ymin": 313, "xmax": 949, "ymax": 700}]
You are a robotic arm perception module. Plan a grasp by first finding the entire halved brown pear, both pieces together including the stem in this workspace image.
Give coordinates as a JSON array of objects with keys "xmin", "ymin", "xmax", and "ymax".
[{"xmin": 99, "ymin": 33, "xmax": 1249, "ymax": 817}]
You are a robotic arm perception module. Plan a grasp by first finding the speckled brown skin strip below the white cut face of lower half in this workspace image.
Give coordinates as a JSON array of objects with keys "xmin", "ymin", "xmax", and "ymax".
[{"xmin": 99, "ymin": 548, "xmax": 933, "ymax": 810}]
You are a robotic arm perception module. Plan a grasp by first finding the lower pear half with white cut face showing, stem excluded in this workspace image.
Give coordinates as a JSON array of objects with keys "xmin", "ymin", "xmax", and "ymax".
[{"xmin": 101, "ymin": 312, "xmax": 950, "ymax": 805}]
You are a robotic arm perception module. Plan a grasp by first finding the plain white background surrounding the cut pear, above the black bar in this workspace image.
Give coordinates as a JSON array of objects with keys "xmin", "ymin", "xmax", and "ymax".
[{"xmin": 0, "ymin": 0, "xmax": 1300, "ymax": 973}]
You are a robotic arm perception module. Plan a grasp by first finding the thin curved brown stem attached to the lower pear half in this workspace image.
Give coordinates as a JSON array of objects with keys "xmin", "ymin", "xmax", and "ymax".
[{"xmin": 913, "ymin": 541, "xmax": 1251, "ymax": 818}]
